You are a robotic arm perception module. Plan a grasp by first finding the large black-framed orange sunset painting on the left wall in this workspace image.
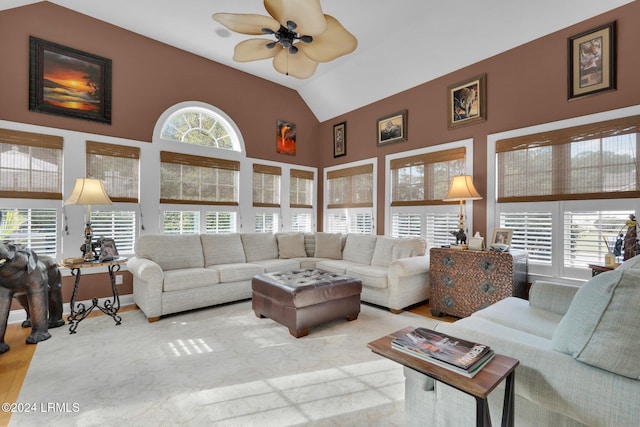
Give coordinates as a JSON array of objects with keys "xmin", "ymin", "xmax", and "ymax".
[{"xmin": 29, "ymin": 37, "xmax": 111, "ymax": 124}]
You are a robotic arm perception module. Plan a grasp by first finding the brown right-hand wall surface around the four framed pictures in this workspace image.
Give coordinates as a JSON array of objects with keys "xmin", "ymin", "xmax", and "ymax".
[{"xmin": 318, "ymin": 1, "xmax": 640, "ymax": 236}]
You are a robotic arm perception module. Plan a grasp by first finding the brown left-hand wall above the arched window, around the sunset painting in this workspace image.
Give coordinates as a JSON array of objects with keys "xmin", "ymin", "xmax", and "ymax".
[{"xmin": 0, "ymin": 2, "xmax": 319, "ymax": 166}]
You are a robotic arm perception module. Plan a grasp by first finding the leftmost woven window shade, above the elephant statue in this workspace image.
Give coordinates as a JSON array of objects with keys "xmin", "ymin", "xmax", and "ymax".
[{"xmin": 0, "ymin": 129, "xmax": 63, "ymax": 200}]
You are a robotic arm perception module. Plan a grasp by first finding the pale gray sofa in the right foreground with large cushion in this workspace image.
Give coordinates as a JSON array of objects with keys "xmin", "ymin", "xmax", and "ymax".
[{"xmin": 405, "ymin": 256, "xmax": 640, "ymax": 427}]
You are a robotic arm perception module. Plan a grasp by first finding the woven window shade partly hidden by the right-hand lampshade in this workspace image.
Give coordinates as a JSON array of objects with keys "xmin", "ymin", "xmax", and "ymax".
[{"xmin": 390, "ymin": 147, "xmax": 466, "ymax": 206}]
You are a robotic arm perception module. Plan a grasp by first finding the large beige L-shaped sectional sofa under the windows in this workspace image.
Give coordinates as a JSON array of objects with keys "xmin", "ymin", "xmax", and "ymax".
[{"xmin": 127, "ymin": 233, "xmax": 429, "ymax": 321}]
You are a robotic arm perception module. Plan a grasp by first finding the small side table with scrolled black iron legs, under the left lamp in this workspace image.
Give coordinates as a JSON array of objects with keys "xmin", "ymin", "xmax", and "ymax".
[{"xmin": 60, "ymin": 258, "xmax": 127, "ymax": 334}]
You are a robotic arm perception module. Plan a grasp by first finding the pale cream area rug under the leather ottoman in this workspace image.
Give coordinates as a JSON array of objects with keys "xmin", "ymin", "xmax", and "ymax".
[{"xmin": 10, "ymin": 301, "xmax": 436, "ymax": 427}]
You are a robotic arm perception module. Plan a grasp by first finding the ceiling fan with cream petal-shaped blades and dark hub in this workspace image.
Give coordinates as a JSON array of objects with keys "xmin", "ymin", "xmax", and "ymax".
[{"xmin": 213, "ymin": 0, "xmax": 358, "ymax": 79}]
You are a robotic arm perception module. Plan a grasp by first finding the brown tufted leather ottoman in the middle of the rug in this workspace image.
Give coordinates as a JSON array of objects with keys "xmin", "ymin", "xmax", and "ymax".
[{"xmin": 251, "ymin": 269, "xmax": 362, "ymax": 338}]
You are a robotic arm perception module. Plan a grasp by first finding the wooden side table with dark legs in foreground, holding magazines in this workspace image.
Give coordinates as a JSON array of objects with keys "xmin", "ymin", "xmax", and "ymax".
[{"xmin": 367, "ymin": 326, "xmax": 520, "ymax": 427}]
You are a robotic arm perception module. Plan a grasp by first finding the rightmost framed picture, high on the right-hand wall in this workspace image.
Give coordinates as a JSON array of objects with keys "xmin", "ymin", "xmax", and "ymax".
[{"xmin": 568, "ymin": 22, "xmax": 616, "ymax": 99}]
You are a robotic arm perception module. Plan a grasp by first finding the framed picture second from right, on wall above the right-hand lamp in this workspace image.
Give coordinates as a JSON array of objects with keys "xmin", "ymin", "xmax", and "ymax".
[{"xmin": 447, "ymin": 74, "xmax": 487, "ymax": 129}]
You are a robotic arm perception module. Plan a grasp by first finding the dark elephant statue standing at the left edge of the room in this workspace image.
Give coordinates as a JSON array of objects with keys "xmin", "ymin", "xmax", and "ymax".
[{"xmin": 0, "ymin": 243, "xmax": 64, "ymax": 354}]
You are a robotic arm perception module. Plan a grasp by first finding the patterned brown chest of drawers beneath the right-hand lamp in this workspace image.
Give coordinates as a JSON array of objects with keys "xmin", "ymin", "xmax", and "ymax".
[{"xmin": 429, "ymin": 248, "xmax": 528, "ymax": 317}]
